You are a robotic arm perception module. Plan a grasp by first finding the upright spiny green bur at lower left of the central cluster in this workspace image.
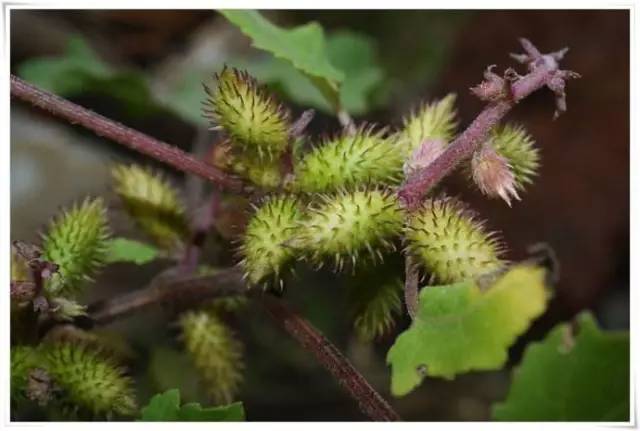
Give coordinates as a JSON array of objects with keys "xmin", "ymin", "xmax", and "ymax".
[{"xmin": 240, "ymin": 196, "xmax": 302, "ymax": 286}]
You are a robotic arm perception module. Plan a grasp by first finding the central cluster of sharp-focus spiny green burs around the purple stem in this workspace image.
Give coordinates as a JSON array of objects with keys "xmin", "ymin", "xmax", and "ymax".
[{"xmin": 205, "ymin": 68, "xmax": 539, "ymax": 294}]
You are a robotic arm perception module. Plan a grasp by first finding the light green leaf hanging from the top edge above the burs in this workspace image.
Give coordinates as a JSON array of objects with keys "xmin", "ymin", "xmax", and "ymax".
[{"xmin": 220, "ymin": 10, "xmax": 344, "ymax": 111}]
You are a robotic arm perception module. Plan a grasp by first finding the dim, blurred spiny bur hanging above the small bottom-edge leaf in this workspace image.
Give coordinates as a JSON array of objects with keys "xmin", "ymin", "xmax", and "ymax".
[{"xmin": 180, "ymin": 311, "xmax": 244, "ymax": 404}]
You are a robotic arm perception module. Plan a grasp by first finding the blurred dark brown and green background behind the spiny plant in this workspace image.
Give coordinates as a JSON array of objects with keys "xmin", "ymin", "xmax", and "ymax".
[{"xmin": 11, "ymin": 10, "xmax": 629, "ymax": 420}]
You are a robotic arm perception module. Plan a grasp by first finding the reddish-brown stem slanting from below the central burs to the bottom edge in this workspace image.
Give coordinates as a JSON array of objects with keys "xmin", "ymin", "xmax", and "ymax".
[{"xmin": 263, "ymin": 297, "xmax": 400, "ymax": 421}]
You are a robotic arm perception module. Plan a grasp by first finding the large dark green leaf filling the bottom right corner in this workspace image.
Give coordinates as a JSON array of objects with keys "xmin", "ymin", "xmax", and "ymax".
[{"xmin": 493, "ymin": 312, "xmax": 630, "ymax": 422}]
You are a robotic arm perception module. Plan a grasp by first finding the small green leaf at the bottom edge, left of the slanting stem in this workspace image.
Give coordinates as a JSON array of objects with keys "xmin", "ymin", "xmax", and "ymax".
[{"xmin": 140, "ymin": 389, "xmax": 245, "ymax": 422}]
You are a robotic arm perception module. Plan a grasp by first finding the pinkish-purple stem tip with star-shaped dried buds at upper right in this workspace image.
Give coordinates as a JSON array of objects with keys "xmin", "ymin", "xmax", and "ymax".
[{"xmin": 398, "ymin": 39, "xmax": 579, "ymax": 210}]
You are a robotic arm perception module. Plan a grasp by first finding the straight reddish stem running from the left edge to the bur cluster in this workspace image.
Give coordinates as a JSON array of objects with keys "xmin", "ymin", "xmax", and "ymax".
[{"xmin": 11, "ymin": 75, "xmax": 243, "ymax": 192}]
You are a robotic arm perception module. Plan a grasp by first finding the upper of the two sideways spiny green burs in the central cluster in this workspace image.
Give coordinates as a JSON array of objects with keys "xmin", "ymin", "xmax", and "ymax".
[{"xmin": 293, "ymin": 126, "xmax": 404, "ymax": 193}]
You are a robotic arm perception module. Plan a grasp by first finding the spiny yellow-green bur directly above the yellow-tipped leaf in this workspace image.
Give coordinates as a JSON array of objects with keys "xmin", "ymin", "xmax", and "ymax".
[{"xmin": 405, "ymin": 198, "xmax": 504, "ymax": 283}]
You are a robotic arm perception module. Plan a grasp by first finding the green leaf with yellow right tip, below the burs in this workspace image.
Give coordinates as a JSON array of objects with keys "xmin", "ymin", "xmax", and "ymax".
[{"xmin": 387, "ymin": 265, "xmax": 548, "ymax": 396}]
